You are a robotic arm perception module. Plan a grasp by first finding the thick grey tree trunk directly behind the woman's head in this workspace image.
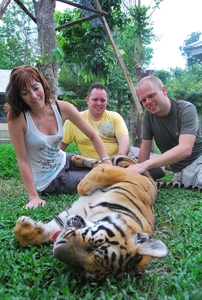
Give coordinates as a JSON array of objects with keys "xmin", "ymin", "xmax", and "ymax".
[{"xmin": 33, "ymin": 0, "xmax": 59, "ymax": 99}]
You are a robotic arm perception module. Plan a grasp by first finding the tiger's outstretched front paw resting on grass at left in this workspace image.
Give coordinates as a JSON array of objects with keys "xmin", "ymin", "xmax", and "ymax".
[{"xmin": 13, "ymin": 216, "xmax": 47, "ymax": 247}]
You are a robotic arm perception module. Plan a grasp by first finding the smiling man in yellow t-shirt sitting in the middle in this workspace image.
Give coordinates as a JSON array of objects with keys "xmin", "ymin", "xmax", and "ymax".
[{"xmin": 60, "ymin": 82, "xmax": 165, "ymax": 179}]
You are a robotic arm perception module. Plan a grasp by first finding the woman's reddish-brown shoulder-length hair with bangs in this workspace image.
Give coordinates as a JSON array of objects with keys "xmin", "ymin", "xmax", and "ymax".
[{"xmin": 4, "ymin": 65, "xmax": 53, "ymax": 121}]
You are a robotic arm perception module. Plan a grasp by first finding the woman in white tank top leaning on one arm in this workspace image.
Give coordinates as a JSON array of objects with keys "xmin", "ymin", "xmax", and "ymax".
[{"xmin": 5, "ymin": 65, "xmax": 111, "ymax": 208}]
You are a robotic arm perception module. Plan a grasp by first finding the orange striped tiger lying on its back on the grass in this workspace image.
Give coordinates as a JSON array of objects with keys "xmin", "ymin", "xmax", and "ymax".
[{"xmin": 14, "ymin": 156, "xmax": 168, "ymax": 281}]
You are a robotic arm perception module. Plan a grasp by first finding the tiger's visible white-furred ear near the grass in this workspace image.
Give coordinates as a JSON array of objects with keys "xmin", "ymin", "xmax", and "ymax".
[{"xmin": 134, "ymin": 233, "xmax": 168, "ymax": 257}]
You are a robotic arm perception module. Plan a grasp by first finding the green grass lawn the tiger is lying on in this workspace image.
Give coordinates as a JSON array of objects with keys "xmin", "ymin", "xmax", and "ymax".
[{"xmin": 0, "ymin": 145, "xmax": 202, "ymax": 300}]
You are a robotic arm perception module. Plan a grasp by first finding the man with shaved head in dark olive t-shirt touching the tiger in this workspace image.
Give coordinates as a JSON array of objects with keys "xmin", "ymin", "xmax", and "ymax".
[{"xmin": 128, "ymin": 76, "xmax": 202, "ymax": 184}]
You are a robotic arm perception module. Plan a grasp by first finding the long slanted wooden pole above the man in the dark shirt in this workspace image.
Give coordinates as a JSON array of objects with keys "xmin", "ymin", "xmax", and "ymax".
[{"xmin": 93, "ymin": 0, "xmax": 143, "ymax": 119}]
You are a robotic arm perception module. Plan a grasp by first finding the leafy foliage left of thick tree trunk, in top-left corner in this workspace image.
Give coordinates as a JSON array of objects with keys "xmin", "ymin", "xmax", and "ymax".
[{"xmin": 0, "ymin": 0, "xmax": 39, "ymax": 69}]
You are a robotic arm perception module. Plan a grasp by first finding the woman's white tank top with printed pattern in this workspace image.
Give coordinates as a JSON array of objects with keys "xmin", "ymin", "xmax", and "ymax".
[{"xmin": 25, "ymin": 104, "xmax": 66, "ymax": 192}]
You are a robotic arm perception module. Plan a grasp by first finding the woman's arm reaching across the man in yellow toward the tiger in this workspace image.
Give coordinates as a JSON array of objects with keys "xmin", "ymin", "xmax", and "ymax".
[{"xmin": 58, "ymin": 101, "xmax": 111, "ymax": 163}]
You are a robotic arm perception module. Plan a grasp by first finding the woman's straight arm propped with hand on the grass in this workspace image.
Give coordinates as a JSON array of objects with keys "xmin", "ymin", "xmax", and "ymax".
[{"xmin": 8, "ymin": 114, "xmax": 46, "ymax": 208}]
